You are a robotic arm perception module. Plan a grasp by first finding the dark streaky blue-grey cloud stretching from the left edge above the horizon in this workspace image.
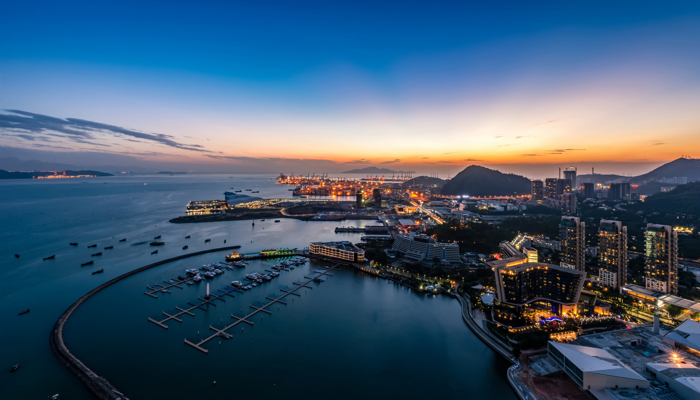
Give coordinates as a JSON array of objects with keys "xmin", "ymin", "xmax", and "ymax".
[{"xmin": 0, "ymin": 110, "xmax": 209, "ymax": 153}]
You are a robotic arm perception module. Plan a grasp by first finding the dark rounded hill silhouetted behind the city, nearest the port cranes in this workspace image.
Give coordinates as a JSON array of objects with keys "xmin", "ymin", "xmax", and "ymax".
[{"xmin": 440, "ymin": 165, "xmax": 532, "ymax": 196}]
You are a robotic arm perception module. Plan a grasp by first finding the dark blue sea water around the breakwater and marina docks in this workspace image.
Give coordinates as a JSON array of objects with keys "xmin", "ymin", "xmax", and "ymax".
[{"xmin": 0, "ymin": 175, "xmax": 514, "ymax": 399}]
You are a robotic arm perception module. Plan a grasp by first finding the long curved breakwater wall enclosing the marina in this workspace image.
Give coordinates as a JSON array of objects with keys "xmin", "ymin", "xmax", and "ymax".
[{"xmin": 49, "ymin": 246, "xmax": 240, "ymax": 400}]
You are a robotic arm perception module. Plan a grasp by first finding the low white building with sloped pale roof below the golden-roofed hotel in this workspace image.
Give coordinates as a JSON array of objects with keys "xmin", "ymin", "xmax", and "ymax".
[{"xmin": 547, "ymin": 341, "xmax": 650, "ymax": 399}]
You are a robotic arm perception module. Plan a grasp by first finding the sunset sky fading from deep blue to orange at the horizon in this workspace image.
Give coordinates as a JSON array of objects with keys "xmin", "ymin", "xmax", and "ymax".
[{"xmin": 0, "ymin": 0, "xmax": 700, "ymax": 176}]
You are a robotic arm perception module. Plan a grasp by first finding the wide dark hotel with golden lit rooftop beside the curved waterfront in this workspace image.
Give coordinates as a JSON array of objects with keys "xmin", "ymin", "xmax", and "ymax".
[{"xmin": 488, "ymin": 257, "xmax": 586, "ymax": 329}]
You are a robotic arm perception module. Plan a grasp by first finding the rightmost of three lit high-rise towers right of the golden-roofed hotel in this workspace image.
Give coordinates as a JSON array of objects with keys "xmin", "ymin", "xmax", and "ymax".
[{"xmin": 644, "ymin": 224, "xmax": 678, "ymax": 295}]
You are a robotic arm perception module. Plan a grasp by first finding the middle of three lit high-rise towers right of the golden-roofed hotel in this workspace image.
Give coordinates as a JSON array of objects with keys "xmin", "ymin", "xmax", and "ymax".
[{"xmin": 598, "ymin": 219, "xmax": 627, "ymax": 288}]
